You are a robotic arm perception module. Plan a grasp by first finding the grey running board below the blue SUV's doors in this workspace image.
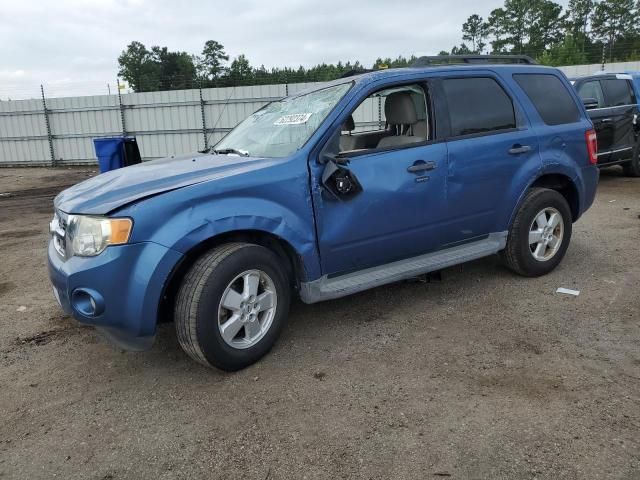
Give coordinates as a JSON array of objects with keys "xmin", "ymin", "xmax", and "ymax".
[{"xmin": 300, "ymin": 232, "xmax": 507, "ymax": 303}]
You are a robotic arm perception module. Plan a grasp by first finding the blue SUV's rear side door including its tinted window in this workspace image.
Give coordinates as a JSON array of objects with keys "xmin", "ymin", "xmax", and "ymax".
[{"xmin": 441, "ymin": 72, "xmax": 541, "ymax": 242}]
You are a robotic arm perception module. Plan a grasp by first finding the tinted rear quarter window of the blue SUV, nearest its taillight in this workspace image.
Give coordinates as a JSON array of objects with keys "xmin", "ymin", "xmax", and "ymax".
[{"xmin": 513, "ymin": 73, "xmax": 580, "ymax": 125}]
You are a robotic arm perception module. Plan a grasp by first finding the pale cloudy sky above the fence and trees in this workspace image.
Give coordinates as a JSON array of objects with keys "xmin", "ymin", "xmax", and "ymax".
[{"xmin": 0, "ymin": 0, "xmax": 565, "ymax": 100}]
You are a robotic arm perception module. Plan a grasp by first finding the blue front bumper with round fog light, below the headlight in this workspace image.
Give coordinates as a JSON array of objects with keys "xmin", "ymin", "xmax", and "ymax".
[{"xmin": 48, "ymin": 241, "xmax": 182, "ymax": 350}]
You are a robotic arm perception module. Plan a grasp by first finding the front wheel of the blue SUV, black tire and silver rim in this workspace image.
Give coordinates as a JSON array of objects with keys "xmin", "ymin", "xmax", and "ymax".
[{"xmin": 174, "ymin": 243, "xmax": 291, "ymax": 371}]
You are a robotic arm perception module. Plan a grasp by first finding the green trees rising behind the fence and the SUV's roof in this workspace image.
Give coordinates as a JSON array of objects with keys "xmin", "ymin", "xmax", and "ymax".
[{"xmin": 118, "ymin": 0, "xmax": 640, "ymax": 92}]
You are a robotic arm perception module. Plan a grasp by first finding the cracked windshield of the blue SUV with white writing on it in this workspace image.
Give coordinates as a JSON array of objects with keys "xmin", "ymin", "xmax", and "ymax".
[{"xmin": 215, "ymin": 83, "xmax": 351, "ymax": 157}]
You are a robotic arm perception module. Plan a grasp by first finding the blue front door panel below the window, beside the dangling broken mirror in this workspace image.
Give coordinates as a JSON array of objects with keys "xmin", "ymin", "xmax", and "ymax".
[{"xmin": 314, "ymin": 143, "xmax": 447, "ymax": 274}]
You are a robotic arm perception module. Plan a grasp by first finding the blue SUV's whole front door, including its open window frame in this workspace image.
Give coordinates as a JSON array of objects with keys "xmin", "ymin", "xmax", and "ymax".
[{"xmin": 310, "ymin": 83, "xmax": 447, "ymax": 275}]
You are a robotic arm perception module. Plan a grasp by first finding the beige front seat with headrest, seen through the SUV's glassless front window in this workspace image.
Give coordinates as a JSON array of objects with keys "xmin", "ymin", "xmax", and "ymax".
[{"xmin": 378, "ymin": 92, "xmax": 427, "ymax": 148}]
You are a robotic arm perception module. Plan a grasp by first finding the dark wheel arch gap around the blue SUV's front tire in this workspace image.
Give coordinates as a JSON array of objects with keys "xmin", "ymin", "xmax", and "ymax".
[{"xmin": 157, "ymin": 229, "xmax": 306, "ymax": 323}]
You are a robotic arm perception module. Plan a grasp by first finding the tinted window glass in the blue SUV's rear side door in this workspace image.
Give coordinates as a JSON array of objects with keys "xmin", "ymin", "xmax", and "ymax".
[{"xmin": 442, "ymin": 77, "xmax": 516, "ymax": 137}]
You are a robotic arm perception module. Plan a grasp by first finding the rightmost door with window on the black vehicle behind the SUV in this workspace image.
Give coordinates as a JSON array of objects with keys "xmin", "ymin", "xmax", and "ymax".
[{"xmin": 598, "ymin": 78, "xmax": 637, "ymax": 162}]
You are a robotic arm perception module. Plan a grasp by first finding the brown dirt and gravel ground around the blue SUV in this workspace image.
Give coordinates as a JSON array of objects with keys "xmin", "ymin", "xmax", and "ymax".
[{"xmin": 0, "ymin": 169, "xmax": 640, "ymax": 480}]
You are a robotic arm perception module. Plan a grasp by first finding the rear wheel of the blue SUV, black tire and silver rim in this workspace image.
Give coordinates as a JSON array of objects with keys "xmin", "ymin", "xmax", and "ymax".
[{"xmin": 501, "ymin": 188, "xmax": 572, "ymax": 277}]
